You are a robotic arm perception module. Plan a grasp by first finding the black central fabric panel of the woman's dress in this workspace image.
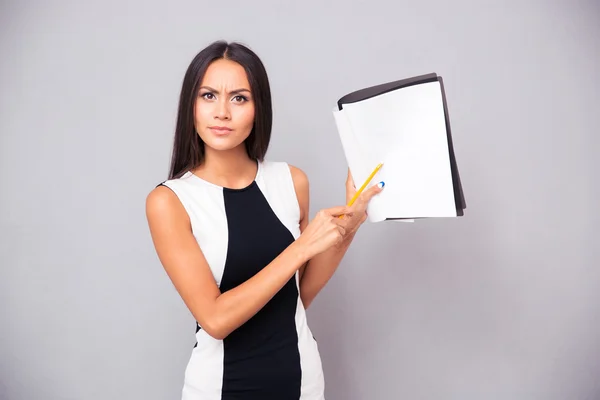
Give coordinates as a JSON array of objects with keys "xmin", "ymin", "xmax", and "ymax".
[{"xmin": 220, "ymin": 182, "xmax": 302, "ymax": 400}]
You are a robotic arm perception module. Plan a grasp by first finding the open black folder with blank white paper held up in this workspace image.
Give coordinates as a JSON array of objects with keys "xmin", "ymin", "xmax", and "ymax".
[{"xmin": 333, "ymin": 73, "xmax": 466, "ymax": 222}]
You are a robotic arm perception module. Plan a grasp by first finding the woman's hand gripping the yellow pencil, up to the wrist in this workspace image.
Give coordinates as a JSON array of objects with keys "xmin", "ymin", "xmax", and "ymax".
[{"xmin": 297, "ymin": 206, "xmax": 349, "ymax": 259}]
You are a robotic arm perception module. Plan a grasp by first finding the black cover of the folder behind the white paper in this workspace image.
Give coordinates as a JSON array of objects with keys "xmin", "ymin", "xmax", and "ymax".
[{"xmin": 337, "ymin": 73, "xmax": 467, "ymax": 219}]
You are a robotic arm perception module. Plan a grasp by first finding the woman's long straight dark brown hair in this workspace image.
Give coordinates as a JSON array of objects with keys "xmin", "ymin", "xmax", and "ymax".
[{"xmin": 169, "ymin": 40, "xmax": 273, "ymax": 179}]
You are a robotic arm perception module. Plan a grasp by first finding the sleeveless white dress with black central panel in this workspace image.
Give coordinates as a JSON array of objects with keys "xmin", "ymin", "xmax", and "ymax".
[{"xmin": 162, "ymin": 161, "xmax": 324, "ymax": 400}]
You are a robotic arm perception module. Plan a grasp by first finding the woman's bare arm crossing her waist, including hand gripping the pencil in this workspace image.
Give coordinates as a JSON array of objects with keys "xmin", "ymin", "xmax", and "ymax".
[{"xmin": 146, "ymin": 186, "xmax": 345, "ymax": 339}]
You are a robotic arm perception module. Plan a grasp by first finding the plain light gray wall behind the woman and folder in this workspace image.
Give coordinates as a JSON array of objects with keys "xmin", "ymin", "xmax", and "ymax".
[{"xmin": 0, "ymin": 0, "xmax": 600, "ymax": 400}]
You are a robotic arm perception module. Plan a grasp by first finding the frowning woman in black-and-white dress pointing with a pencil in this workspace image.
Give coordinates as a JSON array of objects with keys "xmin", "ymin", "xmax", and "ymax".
[{"xmin": 146, "ymin": 42, "xmax": 383, "ymax": 400}]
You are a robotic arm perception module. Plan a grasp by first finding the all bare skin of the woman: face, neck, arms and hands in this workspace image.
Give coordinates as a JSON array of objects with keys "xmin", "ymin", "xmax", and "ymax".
[{"xmin": 146, "ymin": 59, "xmax": 382, "ymax": 339}]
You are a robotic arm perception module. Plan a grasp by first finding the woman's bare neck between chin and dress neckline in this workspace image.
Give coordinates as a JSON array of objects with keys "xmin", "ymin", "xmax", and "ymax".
[{"xmin": 194, "ymin": 143, "xmax": 256, "ymax": 188}]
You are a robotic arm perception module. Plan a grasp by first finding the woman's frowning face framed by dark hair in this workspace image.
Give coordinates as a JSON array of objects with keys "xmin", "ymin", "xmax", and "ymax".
[{"xmin": 194, "ymin": 59, "xmax": 254, "ymax": 155}]
